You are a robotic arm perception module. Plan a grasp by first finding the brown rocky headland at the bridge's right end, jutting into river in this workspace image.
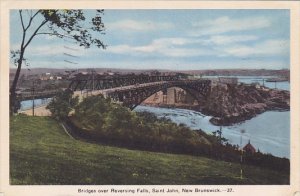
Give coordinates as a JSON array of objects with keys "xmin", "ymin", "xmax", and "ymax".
[{"xmin": 144, "ymin": 84, "xmax": 290, "ymax": 126}]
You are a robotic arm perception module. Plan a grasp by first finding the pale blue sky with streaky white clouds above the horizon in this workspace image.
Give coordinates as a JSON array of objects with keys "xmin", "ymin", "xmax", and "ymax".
[{"xmin": 10, "ymin": 9, "xmax": 290, "ymax": 70}]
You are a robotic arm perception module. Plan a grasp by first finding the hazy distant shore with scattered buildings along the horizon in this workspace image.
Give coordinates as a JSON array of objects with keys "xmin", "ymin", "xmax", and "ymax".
[{"xmin": 9, "ymin": 68, "xmax": 290, "ymax": 91}]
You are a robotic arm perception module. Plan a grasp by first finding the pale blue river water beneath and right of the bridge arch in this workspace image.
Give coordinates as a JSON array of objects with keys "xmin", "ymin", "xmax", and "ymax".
[{"xmin": 135, "ymin": 77, "xmax": 290, "ymax": 158}]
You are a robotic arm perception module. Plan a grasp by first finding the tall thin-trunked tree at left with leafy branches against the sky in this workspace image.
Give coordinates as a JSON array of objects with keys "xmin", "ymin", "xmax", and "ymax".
[{"xmin": 10, "ymin": 10, "xmax": 106, "ymax": 114}]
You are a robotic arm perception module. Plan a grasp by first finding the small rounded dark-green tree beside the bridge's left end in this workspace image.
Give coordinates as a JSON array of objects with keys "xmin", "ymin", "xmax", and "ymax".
[{"xmin": 46, "ymin": 89, "xmax": 79, "ymax": 120}]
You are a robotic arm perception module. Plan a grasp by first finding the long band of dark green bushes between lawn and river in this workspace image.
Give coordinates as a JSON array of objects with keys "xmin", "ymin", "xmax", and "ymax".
[{"xmin": 66, "ymin": 96, "xmax": 289, "ymax": 172}]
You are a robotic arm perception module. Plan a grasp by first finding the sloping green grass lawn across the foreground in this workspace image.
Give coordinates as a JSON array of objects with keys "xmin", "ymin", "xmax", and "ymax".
[{"xmin": 10, "ymin": 115, "xmax": 289, "ymax": 185}]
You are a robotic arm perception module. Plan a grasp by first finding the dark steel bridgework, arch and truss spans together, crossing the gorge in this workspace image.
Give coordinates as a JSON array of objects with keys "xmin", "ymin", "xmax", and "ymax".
[{"xmin": 69, "ymin": 74, "xmax": 212, "ymax": 109}]
